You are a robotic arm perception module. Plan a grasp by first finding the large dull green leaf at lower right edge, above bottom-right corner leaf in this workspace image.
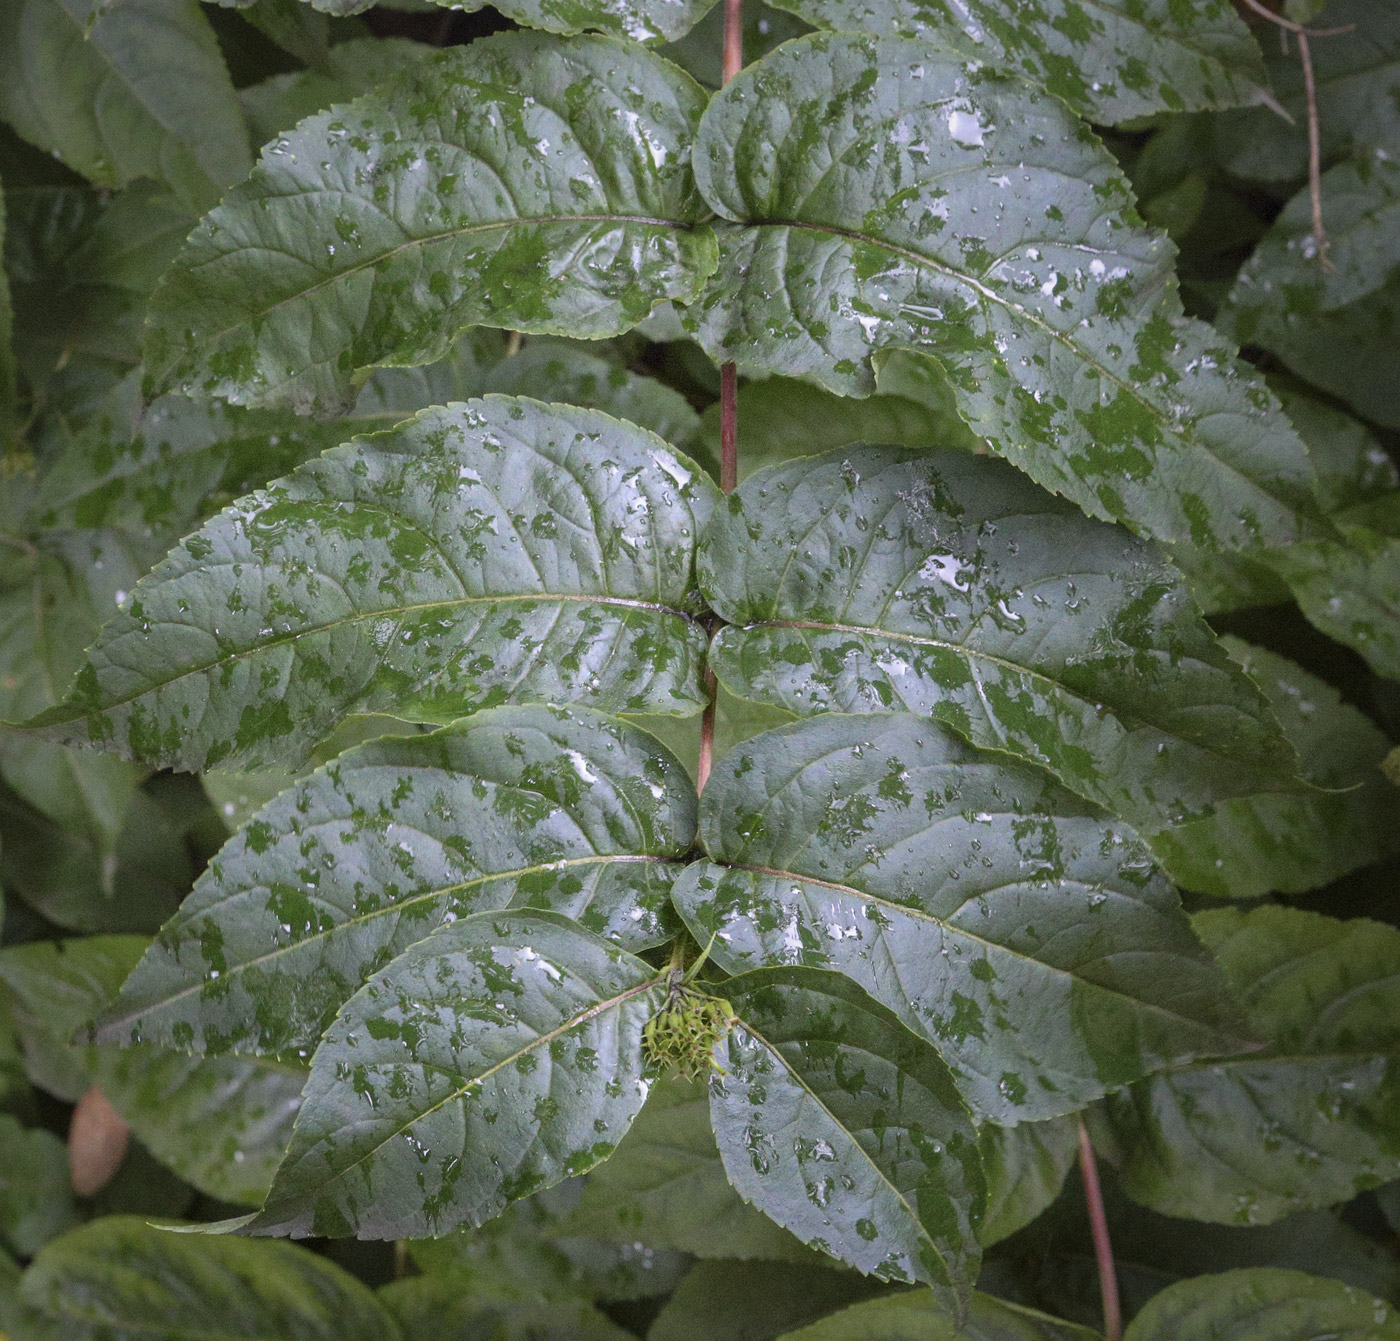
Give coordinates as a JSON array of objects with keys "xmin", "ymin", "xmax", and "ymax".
[{"xmin": 1106, "ymin": 907, "xmax": 1400, "ymax": 1225}]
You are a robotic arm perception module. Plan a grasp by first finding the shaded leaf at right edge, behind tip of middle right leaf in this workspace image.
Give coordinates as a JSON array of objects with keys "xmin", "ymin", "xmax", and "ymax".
[{"xmin": 1151, "ymin": 638, "xmax": 1400, "ymax": 899}]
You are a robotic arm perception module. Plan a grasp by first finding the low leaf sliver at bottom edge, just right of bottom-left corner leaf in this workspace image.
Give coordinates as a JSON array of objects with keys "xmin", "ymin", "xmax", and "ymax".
[{"xmin": 379, "ymin": 1275, "xmax": 636, "ymax": 1341}]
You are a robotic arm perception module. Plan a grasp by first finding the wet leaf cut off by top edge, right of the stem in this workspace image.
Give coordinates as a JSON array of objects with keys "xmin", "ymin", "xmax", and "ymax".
[{"xmin": 781, "ymin": 0, "xmax": 1271, "ymax": 125}]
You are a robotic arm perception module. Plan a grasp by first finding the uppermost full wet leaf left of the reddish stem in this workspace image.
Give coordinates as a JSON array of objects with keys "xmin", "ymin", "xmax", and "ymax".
[{"xmin": 146, "ymin": 34, "xmax": 714, "ymax": 413}]
